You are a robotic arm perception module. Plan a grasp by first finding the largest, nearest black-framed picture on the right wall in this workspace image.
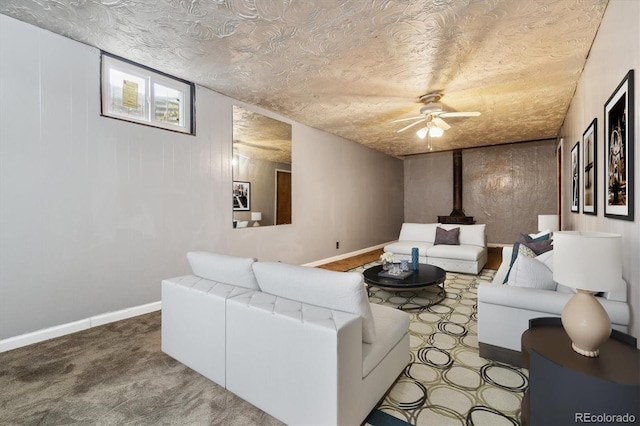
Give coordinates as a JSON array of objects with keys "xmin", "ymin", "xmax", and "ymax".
[{"xmin": 604, "ymin": 70, "xmax": 635, "ymax": 220}]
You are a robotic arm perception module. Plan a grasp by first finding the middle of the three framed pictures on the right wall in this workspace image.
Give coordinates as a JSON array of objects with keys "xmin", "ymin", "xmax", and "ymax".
[{"xmin": 582, "ymin": 118, "xmax": 598, "ymax": 214}]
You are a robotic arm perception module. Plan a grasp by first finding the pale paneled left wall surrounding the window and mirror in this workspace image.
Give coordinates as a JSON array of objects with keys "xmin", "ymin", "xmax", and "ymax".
[{"xmin": 0, "ymin": 15, "xmax": 403, "ymax": 342}]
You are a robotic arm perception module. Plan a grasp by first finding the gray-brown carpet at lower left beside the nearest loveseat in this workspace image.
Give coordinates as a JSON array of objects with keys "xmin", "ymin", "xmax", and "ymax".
[{"xmin": 0, "ymin": 312, "xmax": 282, "ymax": 426}]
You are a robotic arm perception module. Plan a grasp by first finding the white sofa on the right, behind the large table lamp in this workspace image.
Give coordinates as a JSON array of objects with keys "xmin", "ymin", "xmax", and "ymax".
[{"xmin": 478, "ymin": 246, "xmax": 630, "ymax": 366}]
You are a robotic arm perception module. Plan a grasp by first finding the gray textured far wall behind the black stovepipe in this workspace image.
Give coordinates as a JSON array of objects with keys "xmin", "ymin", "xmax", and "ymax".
[{"xmin": 404, "ymin": 141, "xmax": 558, "ymax": 244}]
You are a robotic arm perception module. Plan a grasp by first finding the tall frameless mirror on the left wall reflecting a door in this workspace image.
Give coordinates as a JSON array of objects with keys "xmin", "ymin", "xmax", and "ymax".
[{"xmin": 232, "ymin": 105, "xmax": 291, "ymax": 228}]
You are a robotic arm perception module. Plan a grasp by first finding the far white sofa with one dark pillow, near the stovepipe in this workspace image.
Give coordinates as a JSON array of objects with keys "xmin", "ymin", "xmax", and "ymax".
[{"xmin": 384, "ymin": 223, "xmax": 487, "ymax": 274}]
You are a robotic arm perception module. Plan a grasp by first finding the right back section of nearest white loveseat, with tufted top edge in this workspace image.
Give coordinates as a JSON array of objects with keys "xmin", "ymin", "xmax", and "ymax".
[{"xmin": 226, "ymin": 292, "xmax": 366, "ymax": 424}]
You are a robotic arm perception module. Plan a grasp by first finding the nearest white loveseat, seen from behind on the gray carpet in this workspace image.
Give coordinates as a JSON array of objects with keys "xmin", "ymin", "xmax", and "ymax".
[{"xmin": 162, "ymin": 252, "xmax": 409, "ymax": 425}]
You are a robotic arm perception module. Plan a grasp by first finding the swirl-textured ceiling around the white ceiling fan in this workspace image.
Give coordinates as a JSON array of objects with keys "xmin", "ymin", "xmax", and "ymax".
[{"xmin": 0, "ymin": 0, "xmax": 607, "ymax": 156}]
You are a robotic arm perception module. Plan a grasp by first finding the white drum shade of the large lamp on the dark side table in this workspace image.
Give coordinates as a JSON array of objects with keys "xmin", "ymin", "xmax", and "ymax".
[{"xmin": 553, "ymin": 231, "xmax": 622, "ymax": 292}]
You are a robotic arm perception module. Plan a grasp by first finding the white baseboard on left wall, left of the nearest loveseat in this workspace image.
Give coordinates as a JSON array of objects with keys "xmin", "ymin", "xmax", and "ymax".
[{"xmin": 0, "ymin": 302, "xmax": 162, "ymax": 353}]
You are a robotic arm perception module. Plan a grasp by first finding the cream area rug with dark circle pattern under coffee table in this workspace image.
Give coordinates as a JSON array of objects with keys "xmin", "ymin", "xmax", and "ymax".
[{"xmin": 353, "ymin": 262, "xmax": 529, "ymax": 426}]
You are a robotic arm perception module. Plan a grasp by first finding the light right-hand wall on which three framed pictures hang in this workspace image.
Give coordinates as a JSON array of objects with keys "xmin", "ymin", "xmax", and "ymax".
[{"xmin": 560, "ymin": 0, "xmax": 640, "ymax": 338}]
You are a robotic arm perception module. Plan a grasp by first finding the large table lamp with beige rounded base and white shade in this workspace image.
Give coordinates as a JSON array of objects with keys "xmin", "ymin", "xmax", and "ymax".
[{"xmin": 553, "ymin": 231, "xmax": 622, "ymax": 357}]
